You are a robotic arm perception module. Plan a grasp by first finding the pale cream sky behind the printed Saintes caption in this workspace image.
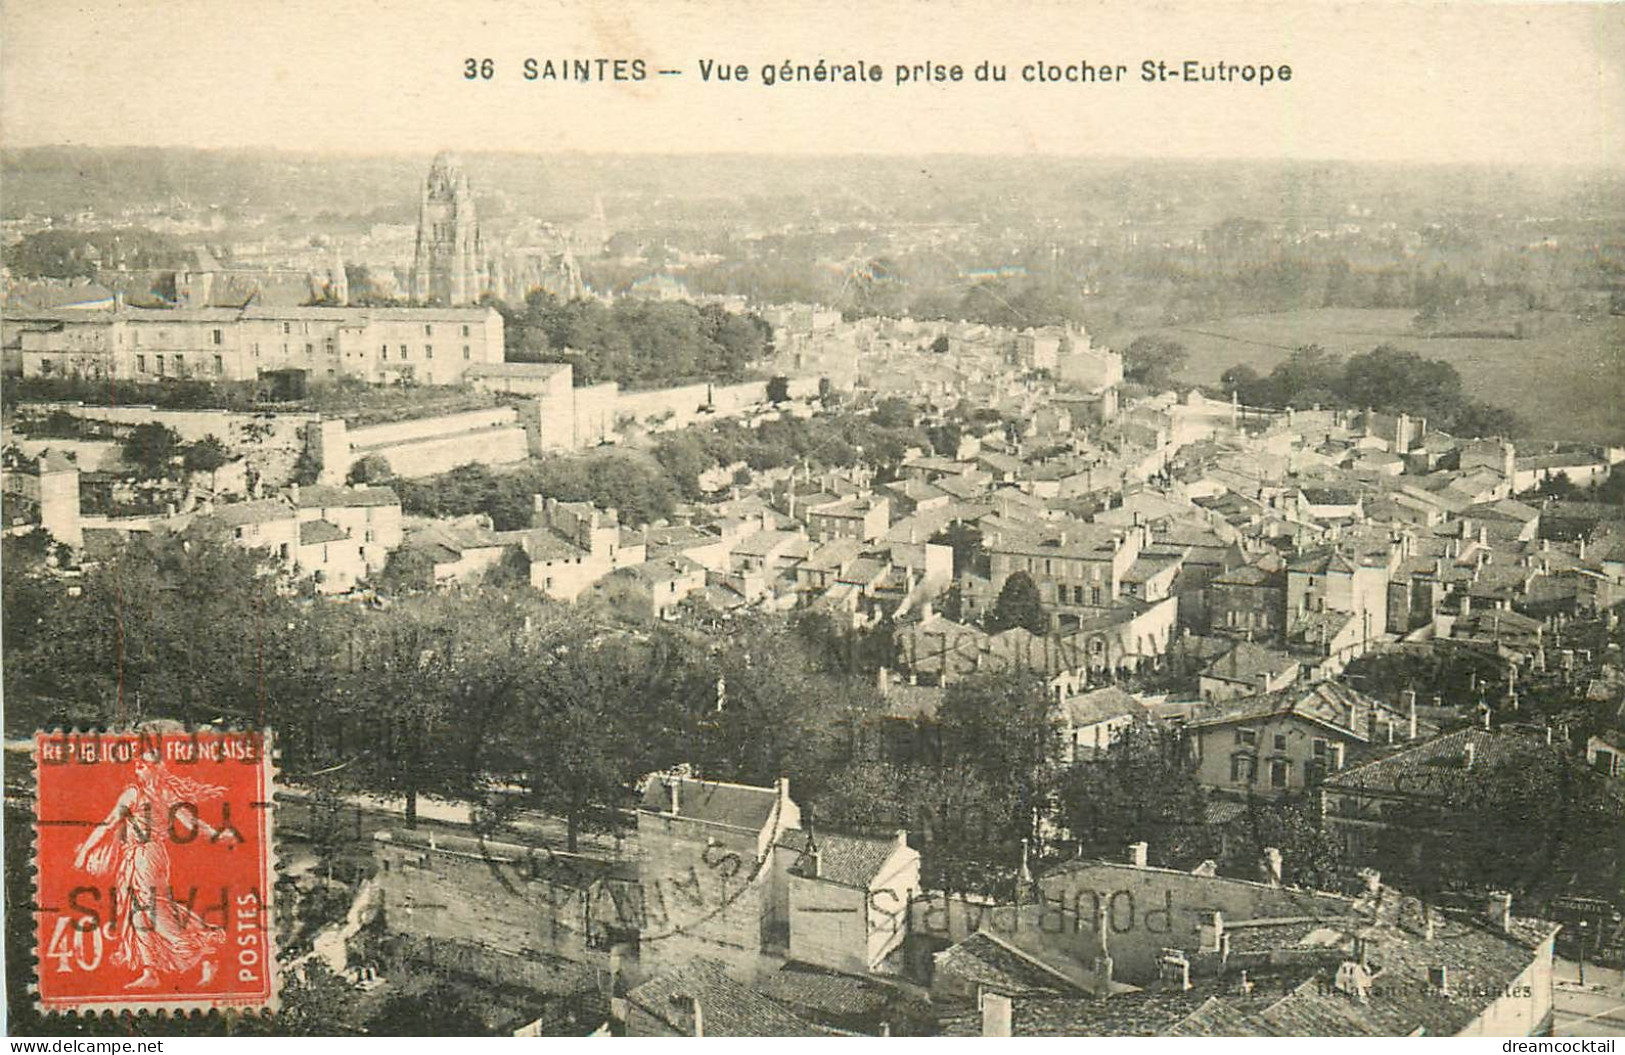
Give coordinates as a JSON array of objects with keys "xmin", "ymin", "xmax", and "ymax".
[{"xmin": 0, "ymin": 0, "xmax": 1625, "ymax": 166}]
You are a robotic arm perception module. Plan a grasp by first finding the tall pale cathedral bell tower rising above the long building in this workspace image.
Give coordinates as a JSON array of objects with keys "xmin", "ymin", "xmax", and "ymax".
[{"xmin": 411, "ymin": 153, "xmax": 484, "ymax": 306}]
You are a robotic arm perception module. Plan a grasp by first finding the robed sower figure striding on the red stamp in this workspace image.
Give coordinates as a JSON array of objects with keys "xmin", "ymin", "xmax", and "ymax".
[{"xmin": 73, "ymin": 753, "xmax": 241, "ymax": 988}]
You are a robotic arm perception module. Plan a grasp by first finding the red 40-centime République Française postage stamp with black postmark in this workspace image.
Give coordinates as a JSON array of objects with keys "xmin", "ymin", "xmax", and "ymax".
[{"xmin": 34, "ymin": 730, "xmax": 276, "ymax": 1011}]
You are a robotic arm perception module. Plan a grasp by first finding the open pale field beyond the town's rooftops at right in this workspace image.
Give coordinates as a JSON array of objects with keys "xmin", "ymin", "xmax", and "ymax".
[{"xmin": 1108, "ymin": 307, "xmax": 1625, "ymax": 442}]
